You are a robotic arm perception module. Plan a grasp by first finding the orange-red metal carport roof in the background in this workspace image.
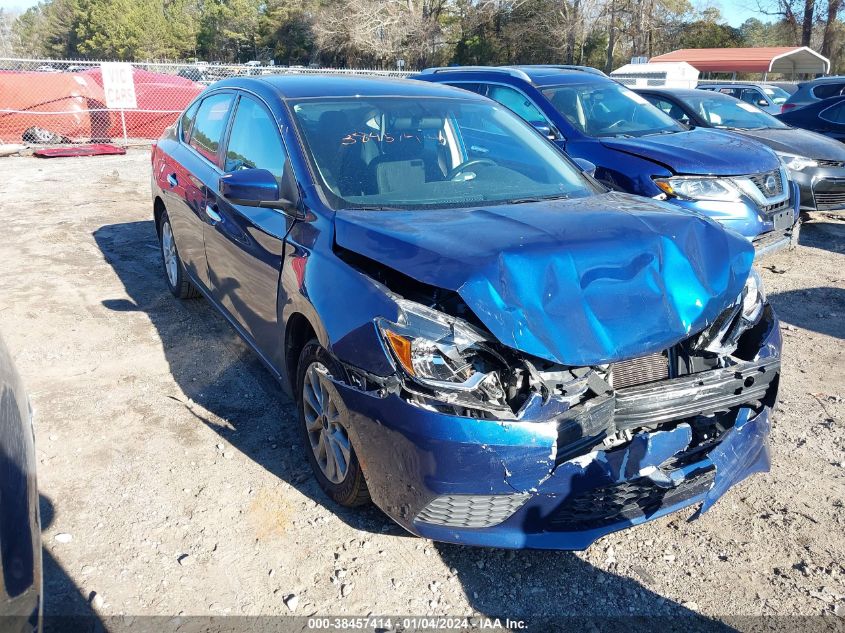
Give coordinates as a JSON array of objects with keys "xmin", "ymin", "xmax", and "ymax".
[{"xmin": 649, "ymin": 46, "xmax": 830, "ymax": 76}]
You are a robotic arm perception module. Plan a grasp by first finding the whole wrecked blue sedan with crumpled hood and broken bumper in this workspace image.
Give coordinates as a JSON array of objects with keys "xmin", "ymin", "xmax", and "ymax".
[{"xmin": 152, "ymin": 76, "xmax": 781, "ymax": 549}]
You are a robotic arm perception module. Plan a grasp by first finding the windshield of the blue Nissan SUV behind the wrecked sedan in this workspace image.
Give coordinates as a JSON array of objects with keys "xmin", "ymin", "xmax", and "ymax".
[{"xmin": 543, "ymin": 82, "xmax": 686, "ymax": 137}]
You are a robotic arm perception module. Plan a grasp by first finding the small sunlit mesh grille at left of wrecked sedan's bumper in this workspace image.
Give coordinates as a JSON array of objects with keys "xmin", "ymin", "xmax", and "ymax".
[{"xmin": 417, "ymin": 494, "xmax": 531, "ymax": 528}]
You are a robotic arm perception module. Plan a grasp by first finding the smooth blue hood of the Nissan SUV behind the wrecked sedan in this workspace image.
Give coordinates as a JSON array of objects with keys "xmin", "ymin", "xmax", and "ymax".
[{"xmin": 601, "ymin": 128, "xmax": 780, "ymax": 176}]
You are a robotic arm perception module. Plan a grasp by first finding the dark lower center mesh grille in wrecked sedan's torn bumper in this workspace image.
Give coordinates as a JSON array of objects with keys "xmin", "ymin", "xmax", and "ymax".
[{"xmin": 548, "ymin": 466, "xmax": 716, "ymax": 532}]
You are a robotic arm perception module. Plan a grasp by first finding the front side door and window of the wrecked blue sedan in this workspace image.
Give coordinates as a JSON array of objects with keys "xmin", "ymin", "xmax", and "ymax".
[{"xmin": 205, "ymin": 94, "xmax": 293, "ymax": 362}]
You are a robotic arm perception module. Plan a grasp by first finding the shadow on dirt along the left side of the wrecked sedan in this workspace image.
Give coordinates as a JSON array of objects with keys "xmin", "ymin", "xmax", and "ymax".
[{"xmin": 94, "ymin": 220, "xmax": 405, "ymax": 535}]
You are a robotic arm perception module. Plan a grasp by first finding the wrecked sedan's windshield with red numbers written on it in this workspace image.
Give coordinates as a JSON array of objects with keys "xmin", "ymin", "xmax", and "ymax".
[{"xmin": 290, "ymin": 97, "xmax": 596, "ymax": 209}]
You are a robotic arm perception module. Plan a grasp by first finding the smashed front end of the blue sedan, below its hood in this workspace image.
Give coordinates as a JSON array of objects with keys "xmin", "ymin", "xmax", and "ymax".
[{"xmin": 331, "ymin": 262, "xmax": 781, "ymax": 549}]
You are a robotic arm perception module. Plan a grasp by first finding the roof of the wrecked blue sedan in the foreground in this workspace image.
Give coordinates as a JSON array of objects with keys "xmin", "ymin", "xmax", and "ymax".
[{"xmin": 211, "ymin": 74, "xmax": 484, "ymax": 100}]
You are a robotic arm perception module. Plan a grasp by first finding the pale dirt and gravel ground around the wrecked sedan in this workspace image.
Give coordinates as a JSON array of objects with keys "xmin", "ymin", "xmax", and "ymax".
[{"xmin": 0, "ymin": 150, "xmax": 845, "ymax": 628}]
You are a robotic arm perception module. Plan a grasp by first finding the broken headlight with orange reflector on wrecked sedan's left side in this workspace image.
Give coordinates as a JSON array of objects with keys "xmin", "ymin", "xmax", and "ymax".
[{"xmin": 377, "ymin": 299, "xmax": 501, "ymax": 396}]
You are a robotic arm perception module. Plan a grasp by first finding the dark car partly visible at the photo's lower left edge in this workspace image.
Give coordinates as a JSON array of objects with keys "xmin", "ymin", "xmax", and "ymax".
[{"xmin": 0, "ymin": 339, "xmax": 42, "ymax": 633}]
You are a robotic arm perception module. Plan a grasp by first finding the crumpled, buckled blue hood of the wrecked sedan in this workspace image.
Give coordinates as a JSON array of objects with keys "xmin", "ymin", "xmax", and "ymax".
[{"xmin": 335, "ymin": 193, "xmax": 754, "ymax": 365}]
